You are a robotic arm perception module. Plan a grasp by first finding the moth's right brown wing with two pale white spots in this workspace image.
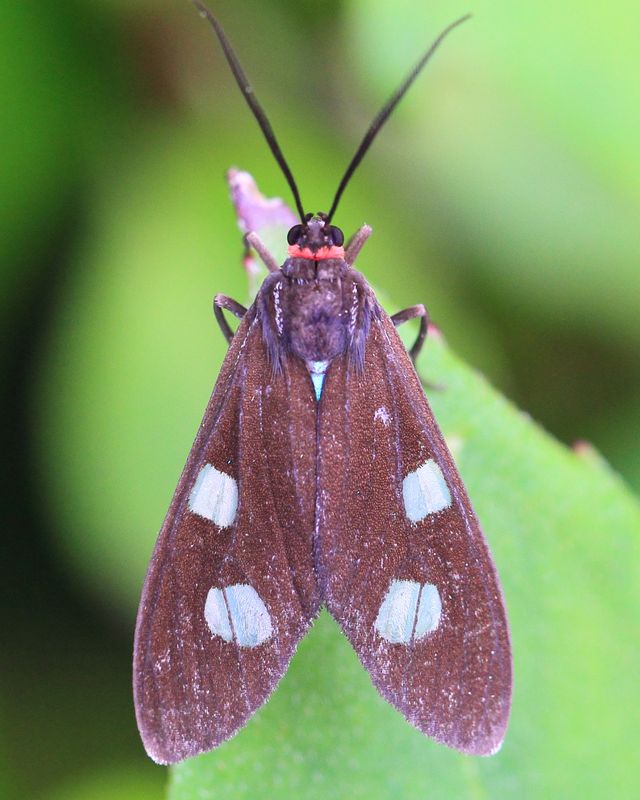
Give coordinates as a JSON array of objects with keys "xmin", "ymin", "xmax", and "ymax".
[{"xmin": 317, "ymin": 313, "xmax": 511, "ymax": 755}]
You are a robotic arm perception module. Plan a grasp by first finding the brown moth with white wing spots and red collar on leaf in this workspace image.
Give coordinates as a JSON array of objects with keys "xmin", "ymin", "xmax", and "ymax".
[{"xmin": 134, "ymin": 2, "xmax": 512, "ymax": 764}]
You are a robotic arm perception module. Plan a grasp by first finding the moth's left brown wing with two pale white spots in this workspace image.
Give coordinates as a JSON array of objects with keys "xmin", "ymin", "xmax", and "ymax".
[{"xmin": 134, "ymin": 309, "xmax": 320, "ymax": 763}]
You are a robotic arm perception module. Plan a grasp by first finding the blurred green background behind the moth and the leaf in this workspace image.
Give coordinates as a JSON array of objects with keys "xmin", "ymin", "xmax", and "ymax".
[{"xmin": 0, "ymin": 0, "xmax": 640, "ymax": 800}]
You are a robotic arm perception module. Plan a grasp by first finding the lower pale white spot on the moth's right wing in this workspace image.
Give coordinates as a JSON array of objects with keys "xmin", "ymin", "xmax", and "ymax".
[{"xmin": 374, "ymin": 580, "xmax": 442, "ymax": 644}]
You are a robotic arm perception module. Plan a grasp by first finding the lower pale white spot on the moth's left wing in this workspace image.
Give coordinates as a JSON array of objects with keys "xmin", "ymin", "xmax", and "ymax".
[{"xmin": 204, "ymin": 583, "xmax": 273, "ymax": 647}]
